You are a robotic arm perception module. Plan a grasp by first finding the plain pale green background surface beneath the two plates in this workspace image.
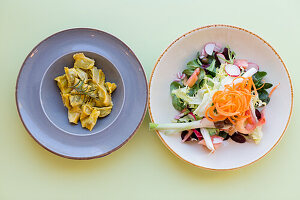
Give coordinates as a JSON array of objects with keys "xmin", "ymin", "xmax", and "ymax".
[{"xmin": 0, "ymin": 0, "xmax": 300, "ymax": 200}]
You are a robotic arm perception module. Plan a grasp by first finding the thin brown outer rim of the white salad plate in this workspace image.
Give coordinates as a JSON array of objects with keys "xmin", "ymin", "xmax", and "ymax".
[{"xmin": 148, "ymin": 24, "xmax": 294, "ymax": 171}]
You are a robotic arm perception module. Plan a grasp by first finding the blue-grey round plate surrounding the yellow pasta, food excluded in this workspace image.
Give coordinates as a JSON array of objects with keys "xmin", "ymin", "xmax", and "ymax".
[{"xmin": 16, "ymin": 28, "xmax": 148, "ymax": 159}]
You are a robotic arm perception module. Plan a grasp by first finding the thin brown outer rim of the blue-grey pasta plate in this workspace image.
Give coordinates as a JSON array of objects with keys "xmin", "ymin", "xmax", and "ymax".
[{"xmin": 15, "ymin": 27, "xmax": 149, "ymax": 160}]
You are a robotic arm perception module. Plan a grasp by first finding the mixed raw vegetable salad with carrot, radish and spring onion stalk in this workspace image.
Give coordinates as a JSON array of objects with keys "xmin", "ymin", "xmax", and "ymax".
[{"xmin": 150, "ymin": 42, "xmax": 278, "ymax": 152}]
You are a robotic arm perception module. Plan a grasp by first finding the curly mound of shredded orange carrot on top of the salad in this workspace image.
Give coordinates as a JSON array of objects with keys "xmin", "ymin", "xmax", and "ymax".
[{"xmin": 205, "ymin": 77, "xmax": 257, "ymax": 124}]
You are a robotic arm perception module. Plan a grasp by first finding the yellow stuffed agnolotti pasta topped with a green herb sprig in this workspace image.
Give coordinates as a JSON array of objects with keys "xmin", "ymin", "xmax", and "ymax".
[{"xmin": 54, "ymin": 53, "xmax": 117, "ymax": 131}]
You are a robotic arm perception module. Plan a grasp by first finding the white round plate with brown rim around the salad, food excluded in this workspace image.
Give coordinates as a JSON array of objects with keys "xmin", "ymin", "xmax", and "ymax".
[{"xmin": 149, "ymin": 25, "xmax": 293, "ymax": 170}]
